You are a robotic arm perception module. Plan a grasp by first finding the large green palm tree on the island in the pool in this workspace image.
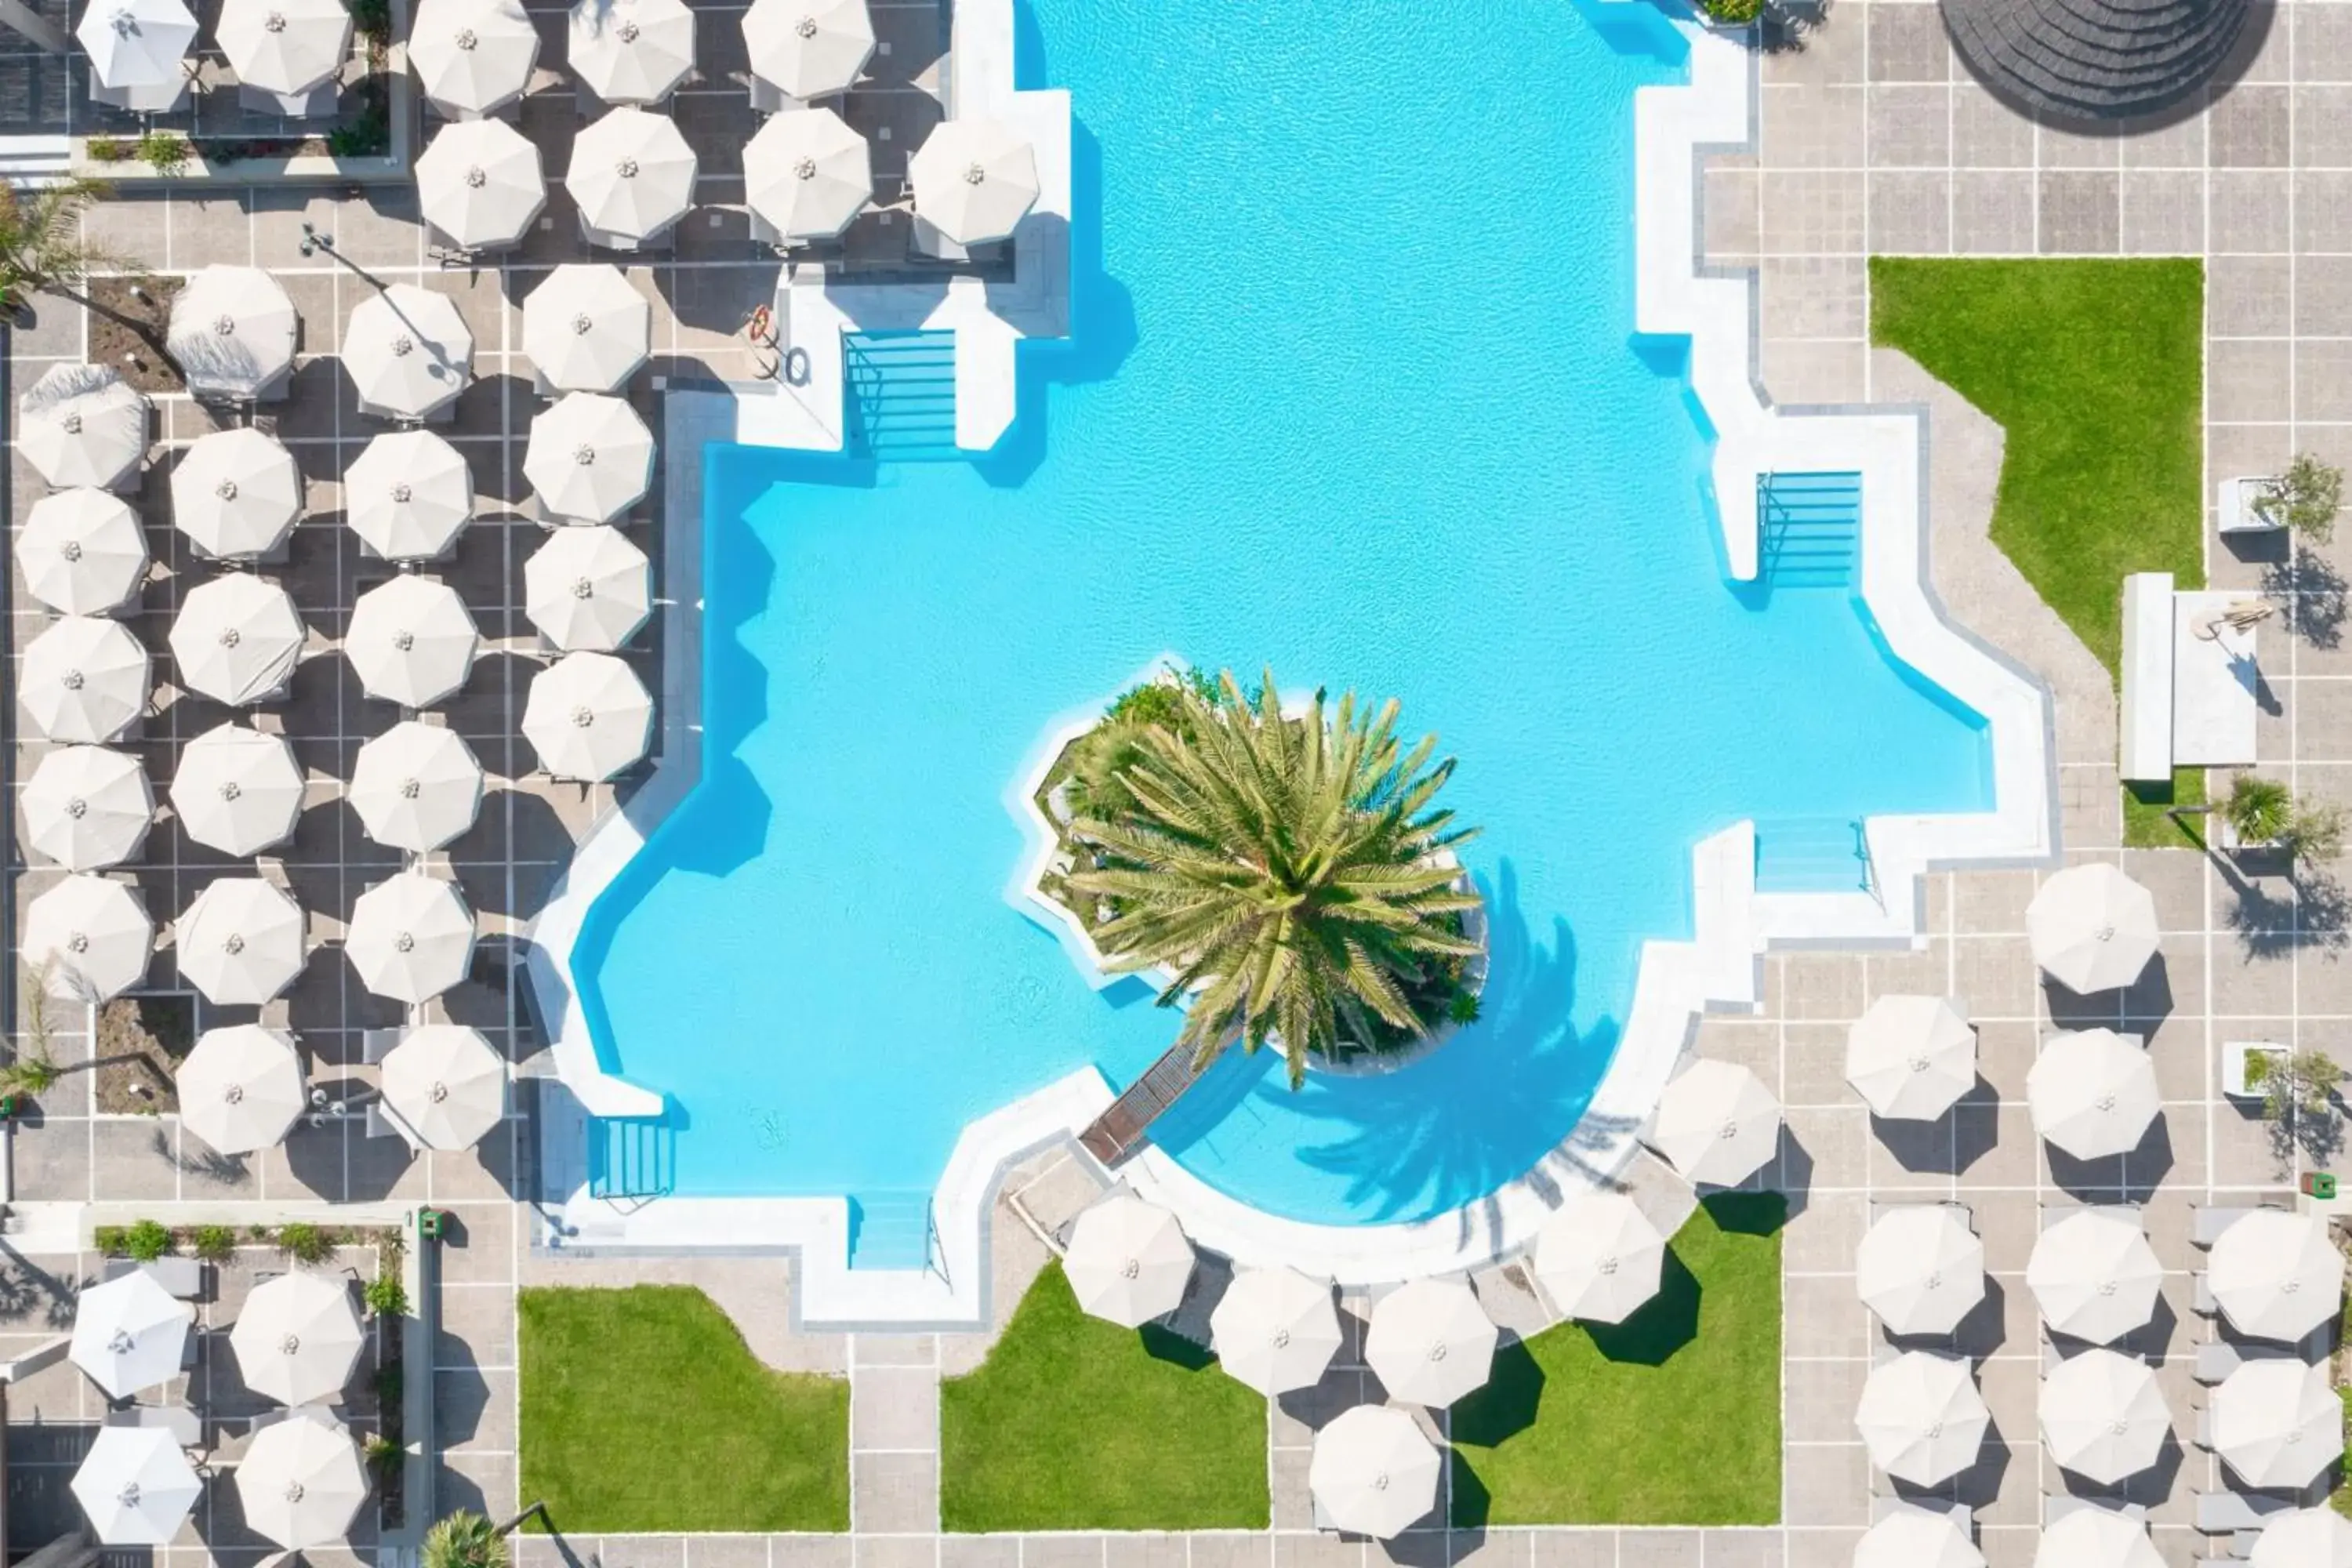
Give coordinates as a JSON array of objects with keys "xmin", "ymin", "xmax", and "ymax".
[{"xmin": 1070, "ymin": 673, "xmax": 1479, "ymax": 1088}]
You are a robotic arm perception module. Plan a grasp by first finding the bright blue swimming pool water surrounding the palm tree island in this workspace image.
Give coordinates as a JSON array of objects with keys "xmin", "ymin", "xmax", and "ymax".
[{"xmin": 579, "ymin": 0, "xmax": 1990, "ymax": 1222}]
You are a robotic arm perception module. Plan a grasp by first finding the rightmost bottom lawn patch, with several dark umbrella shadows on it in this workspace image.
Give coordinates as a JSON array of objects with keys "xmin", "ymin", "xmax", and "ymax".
[{"xmin": 1454, "ymin": 1192, "xmax": 1788, "ymax": 1528}]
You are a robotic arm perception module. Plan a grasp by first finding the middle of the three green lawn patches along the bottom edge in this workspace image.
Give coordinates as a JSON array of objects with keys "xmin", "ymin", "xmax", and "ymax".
[{"xmin": 938, "ymin": 1262, "xmax": 1268, "ymax": 1530}]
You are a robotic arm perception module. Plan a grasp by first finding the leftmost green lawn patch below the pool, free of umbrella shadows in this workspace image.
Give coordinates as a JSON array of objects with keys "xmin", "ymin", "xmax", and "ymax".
[{"xmin": 517, "ymin": 1286, "xmax": 849, "ymax": 1535}]
